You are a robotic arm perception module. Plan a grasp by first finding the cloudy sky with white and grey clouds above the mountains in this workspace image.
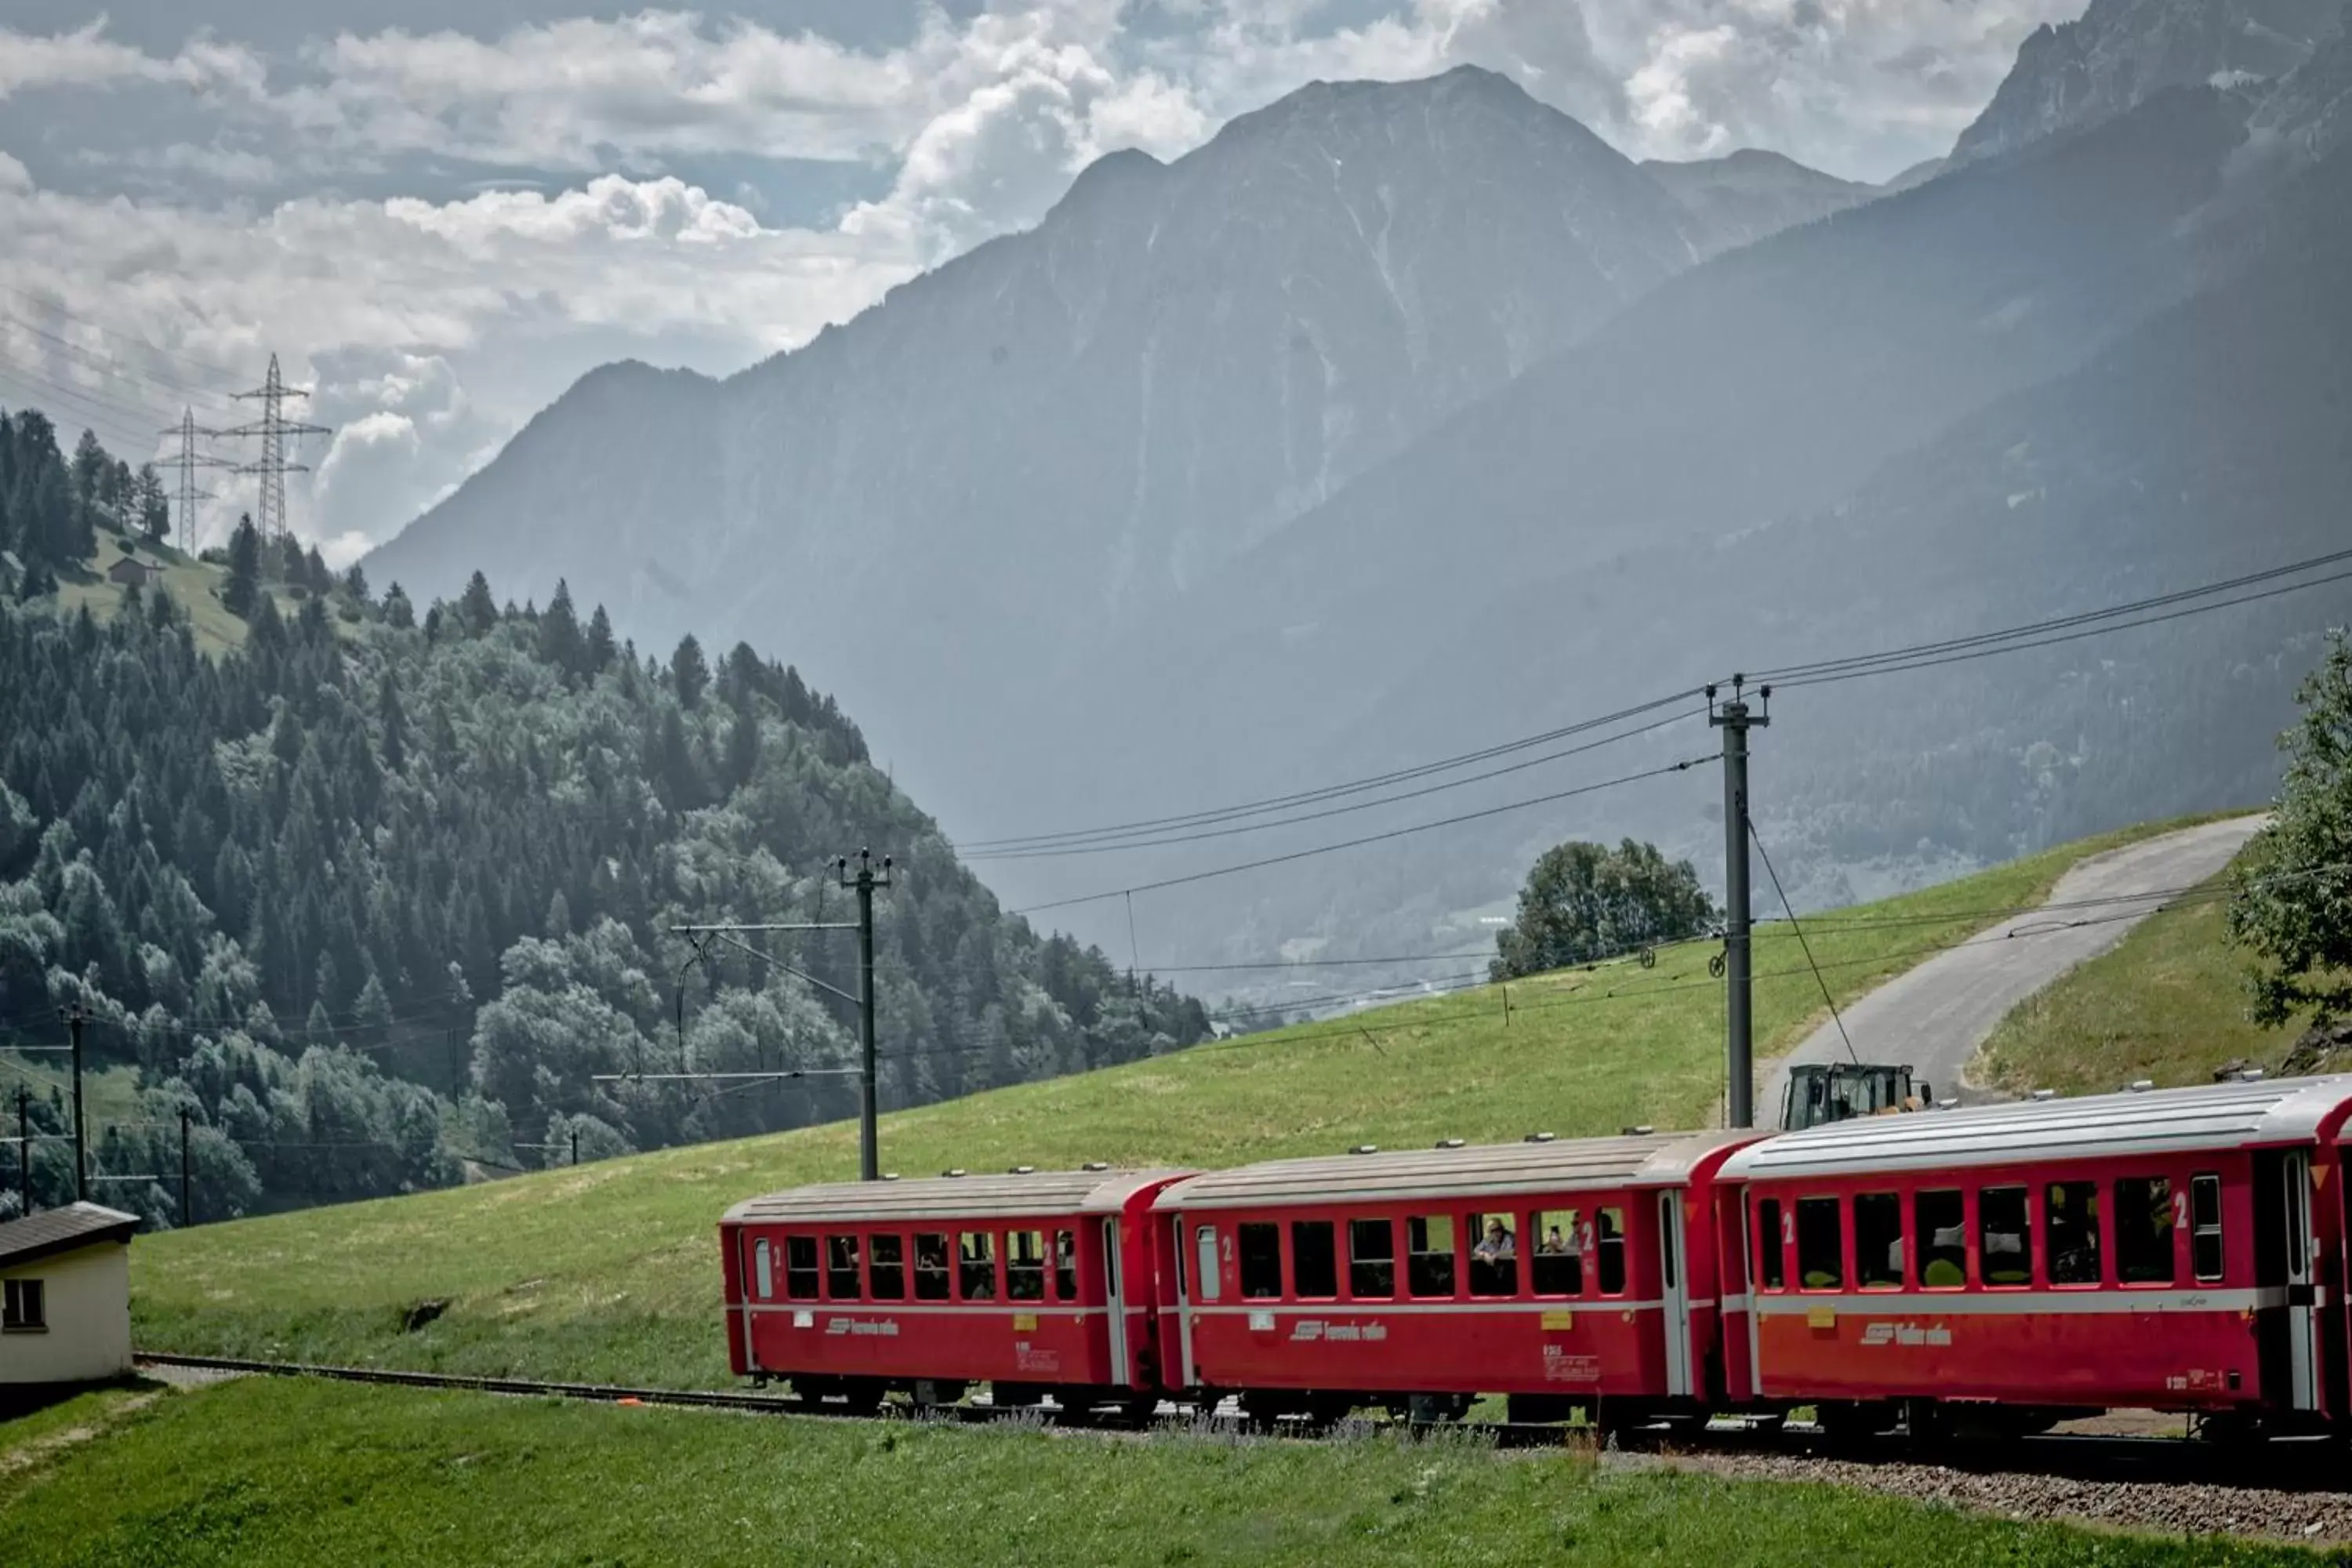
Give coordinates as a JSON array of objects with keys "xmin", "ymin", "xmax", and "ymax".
[{"xmin": 0, "ymin": 0, "xmax": 2082, "ymax": 562}]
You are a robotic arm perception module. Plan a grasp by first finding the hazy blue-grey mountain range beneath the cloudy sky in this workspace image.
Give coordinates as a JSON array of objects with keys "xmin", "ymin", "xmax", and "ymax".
[{"xmin": 367, "ymin": 0, "xmax": 2352, "ymax": 992}]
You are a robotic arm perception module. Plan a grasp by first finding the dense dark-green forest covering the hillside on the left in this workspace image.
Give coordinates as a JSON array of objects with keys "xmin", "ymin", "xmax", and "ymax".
[{"xmin": 0, "ymin": 414, "xmax": 1209, "ymax": 1222}]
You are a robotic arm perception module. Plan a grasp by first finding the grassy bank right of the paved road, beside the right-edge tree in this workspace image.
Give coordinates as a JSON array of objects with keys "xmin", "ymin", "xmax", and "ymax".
[{"xmin": 1980, "ymin": 851, "xmax": 2303, "ymax": 1093}]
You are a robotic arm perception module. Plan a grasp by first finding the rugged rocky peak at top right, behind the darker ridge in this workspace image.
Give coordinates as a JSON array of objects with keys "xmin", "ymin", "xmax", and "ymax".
[{"xmin": 1952, "ymin": 0, "xmax": 2345, "ymax": 158}]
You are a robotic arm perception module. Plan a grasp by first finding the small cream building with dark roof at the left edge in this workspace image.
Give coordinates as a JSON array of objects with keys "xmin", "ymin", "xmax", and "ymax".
[{"xmin": 0, "ymin": 1203, "xmax": 139, "ymax": 1387}]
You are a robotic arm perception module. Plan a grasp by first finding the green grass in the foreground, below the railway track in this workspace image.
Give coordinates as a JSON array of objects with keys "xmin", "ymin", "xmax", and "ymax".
[{"xmin": 0, "ymin": 1377, "xmax": 2319, "ymax": 1568}]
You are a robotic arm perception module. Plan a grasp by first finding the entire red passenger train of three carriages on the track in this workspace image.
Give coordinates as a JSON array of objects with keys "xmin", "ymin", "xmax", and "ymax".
[{"xmin": 720, "ymin": 1076, "xmax": 2352, "ymax": 1432}]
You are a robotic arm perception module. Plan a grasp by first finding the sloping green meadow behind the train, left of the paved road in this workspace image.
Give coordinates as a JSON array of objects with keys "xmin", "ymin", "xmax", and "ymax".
[{"xmin": 132, "ymin": 827, "xmax": 2220, "ymax": 1387}]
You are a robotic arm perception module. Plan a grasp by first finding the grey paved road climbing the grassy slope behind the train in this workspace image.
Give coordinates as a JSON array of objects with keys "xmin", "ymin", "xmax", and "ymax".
[{"xmin": 1757, "ymin": 815, "xmax": 2263, "ymax": 1126}]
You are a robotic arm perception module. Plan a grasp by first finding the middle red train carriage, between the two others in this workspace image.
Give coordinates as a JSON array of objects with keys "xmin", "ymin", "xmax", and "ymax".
[{"xmin": 1155, "ymin": 1133, "xmax": 1762, "ymax": 1420}]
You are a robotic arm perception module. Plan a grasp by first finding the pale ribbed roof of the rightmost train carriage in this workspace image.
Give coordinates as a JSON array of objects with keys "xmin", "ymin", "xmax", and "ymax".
[{"xmin": 1724, "ymin": 1074, "xmax": 2352, "ymax": 1180}]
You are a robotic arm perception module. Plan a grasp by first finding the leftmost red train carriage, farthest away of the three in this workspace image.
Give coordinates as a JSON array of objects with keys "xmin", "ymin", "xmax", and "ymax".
[{"xmin": 720, "ymin": 1168, "xmax": 1183, "ymax": 1408}]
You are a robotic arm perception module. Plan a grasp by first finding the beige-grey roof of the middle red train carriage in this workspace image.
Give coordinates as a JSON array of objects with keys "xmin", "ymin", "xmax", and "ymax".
[{"xmin": 1152, "ymin": 1131, "xmax": 1762, "ymax": 1210}]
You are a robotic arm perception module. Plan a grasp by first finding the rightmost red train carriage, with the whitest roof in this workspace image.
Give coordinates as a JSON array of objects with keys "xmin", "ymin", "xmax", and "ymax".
[{"xmin": 1719, "ymin": 1076, "xmax": 2352, "ymax": 1429}]
